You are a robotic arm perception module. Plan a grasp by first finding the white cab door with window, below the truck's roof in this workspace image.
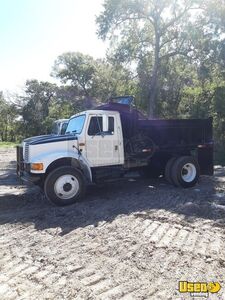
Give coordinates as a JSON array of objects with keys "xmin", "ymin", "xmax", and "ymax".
[{"xmin": 85, "ymin": 115, "xmax": 120, "ymax": 167}]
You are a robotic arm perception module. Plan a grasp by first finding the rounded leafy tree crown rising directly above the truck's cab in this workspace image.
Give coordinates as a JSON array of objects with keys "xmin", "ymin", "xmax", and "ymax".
[{"xmin": 52, "ymin": 52, "xmax": 135, "ymax": 103}]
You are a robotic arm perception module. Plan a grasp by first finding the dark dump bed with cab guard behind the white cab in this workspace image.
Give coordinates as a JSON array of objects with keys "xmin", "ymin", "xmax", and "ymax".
[{"xmin": 97, "ymin": 102, "xmax": 213, "ymax": 175}]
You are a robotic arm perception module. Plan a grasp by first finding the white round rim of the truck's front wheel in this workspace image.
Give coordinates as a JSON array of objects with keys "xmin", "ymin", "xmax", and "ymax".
[{"xmin": 54, "ymin": 174, "xmax": 80, "ymax": 199}]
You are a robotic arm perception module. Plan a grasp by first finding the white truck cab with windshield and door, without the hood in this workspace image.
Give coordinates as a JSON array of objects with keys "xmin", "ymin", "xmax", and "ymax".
[{"xmin": 66, "ymin": 110, "xmax": 124, "ymax": 167}]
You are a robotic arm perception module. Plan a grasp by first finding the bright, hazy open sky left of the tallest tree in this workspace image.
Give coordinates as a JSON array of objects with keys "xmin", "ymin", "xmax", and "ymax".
[{"xmin": 0, "ymin": 0, "xmax": 107, "ymax": 92}]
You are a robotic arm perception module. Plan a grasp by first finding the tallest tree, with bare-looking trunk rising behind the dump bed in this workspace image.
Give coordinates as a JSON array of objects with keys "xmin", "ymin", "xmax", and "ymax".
[{"xmin": 97, "ymin": 0, "xmax": 200, "ymax": 117}]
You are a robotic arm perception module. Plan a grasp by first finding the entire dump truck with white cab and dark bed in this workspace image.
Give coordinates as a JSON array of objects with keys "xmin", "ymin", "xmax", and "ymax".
[{"xmin": 17, "ymin": 96, "xmax": 213, "ymax": 205}]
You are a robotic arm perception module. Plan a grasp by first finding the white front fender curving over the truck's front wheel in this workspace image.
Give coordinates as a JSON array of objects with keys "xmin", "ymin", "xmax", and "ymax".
[{"xmin": 30, "ymin": 151, "xmax": 92, "ymax": 182}]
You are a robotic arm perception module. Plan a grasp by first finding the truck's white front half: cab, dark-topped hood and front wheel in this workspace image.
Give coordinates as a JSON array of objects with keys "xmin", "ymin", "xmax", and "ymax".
[{"xmin": 17, "ymin": 110, "xmax": 124, "ymax": 205}]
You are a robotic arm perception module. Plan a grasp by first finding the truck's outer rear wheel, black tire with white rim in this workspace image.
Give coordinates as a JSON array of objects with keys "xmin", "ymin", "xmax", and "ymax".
[{"xmin": 171, "ymin": 156, "xmax": 200, "ymax": 188}]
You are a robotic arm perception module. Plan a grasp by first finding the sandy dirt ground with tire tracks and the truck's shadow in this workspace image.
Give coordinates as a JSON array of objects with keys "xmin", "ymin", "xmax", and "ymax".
[{"xmin": 0, "ymin": 149, "xmax": 225, "ymax": 300}]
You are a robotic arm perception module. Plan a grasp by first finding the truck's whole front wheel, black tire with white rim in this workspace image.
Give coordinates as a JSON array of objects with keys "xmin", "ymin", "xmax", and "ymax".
[{"xmin": 44, "ymin": 166, "xmax": 85, "ymax": 206}]
